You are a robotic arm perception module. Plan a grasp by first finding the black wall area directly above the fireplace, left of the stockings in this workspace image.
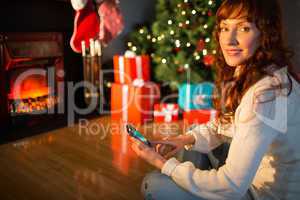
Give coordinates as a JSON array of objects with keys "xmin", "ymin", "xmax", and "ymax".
[{"xmin": 0, "ymin": 0, "xmax": 73, "ymax": 31}]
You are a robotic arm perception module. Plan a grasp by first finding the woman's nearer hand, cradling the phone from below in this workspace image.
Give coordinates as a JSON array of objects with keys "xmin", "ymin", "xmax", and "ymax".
[{"xmin": 130, "ymin": 138, "xmax": 166, "ymax": 169}]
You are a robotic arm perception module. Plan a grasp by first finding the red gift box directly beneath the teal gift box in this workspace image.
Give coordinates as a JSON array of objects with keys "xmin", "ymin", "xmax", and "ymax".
[{"xmin": 183, "ymin": 109, "xmax": 216, "ymax": 124}]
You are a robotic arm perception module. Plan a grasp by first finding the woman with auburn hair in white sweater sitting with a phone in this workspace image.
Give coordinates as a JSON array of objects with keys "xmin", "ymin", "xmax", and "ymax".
[{"xmin": 132, "ymin": 0, "xmax": 300, "ymax": 199}]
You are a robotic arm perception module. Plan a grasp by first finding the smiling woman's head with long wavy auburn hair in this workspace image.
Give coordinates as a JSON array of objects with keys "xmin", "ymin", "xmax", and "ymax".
[{"xmin": 214, "ymin": 0, "xmax": 297, "ymax": 122}]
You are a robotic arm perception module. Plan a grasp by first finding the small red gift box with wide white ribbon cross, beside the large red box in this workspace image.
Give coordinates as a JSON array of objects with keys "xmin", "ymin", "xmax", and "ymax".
[{"xmin": 154, "ymin": 104, "xmax": 179, "ymax": 123}]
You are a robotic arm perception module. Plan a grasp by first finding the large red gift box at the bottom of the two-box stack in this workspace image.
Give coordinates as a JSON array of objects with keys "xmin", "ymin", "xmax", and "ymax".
[{"xmin": 111, "ymin": 82, "xmax": 160, "ymax": 124}]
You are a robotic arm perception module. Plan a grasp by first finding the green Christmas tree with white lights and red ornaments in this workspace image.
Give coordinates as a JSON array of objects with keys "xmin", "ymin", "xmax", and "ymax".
[{"xmin": 127, "ymin": 0, "xmax": 221, "ymax": 90}]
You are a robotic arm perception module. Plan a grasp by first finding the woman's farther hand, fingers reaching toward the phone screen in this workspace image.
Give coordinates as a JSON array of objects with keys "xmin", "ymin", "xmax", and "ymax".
[{"xmin": 151, "ymin": 135, "xmax": 195, "ymax": 159}]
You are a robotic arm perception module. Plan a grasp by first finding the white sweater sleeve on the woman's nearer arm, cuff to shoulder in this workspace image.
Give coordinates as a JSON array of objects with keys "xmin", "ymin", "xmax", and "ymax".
[{"xmin": 161, "ymin": 76, "xmax": 285, "ymax": 199}]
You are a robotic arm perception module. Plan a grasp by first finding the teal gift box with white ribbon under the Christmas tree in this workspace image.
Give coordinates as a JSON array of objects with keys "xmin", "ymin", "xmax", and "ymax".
[{"xmin": 178, "ymin": 82, "xmax": 214, "ymax": 111}]
